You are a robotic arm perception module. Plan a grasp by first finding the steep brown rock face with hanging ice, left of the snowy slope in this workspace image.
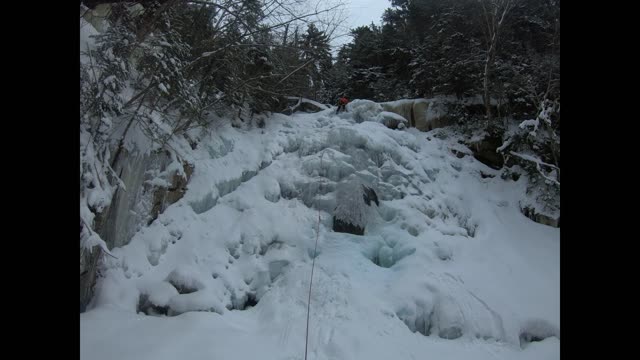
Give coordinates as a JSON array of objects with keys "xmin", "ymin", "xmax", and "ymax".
[{"xmin": 80, "ymin": 150, "xmax": 194, "ymax": 311}]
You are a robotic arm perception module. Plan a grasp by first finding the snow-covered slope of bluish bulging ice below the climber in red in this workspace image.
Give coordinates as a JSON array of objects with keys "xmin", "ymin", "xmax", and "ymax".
[{"xmin": 80, "ymin": 105, "xmax": 560, "ymax": 360}]
